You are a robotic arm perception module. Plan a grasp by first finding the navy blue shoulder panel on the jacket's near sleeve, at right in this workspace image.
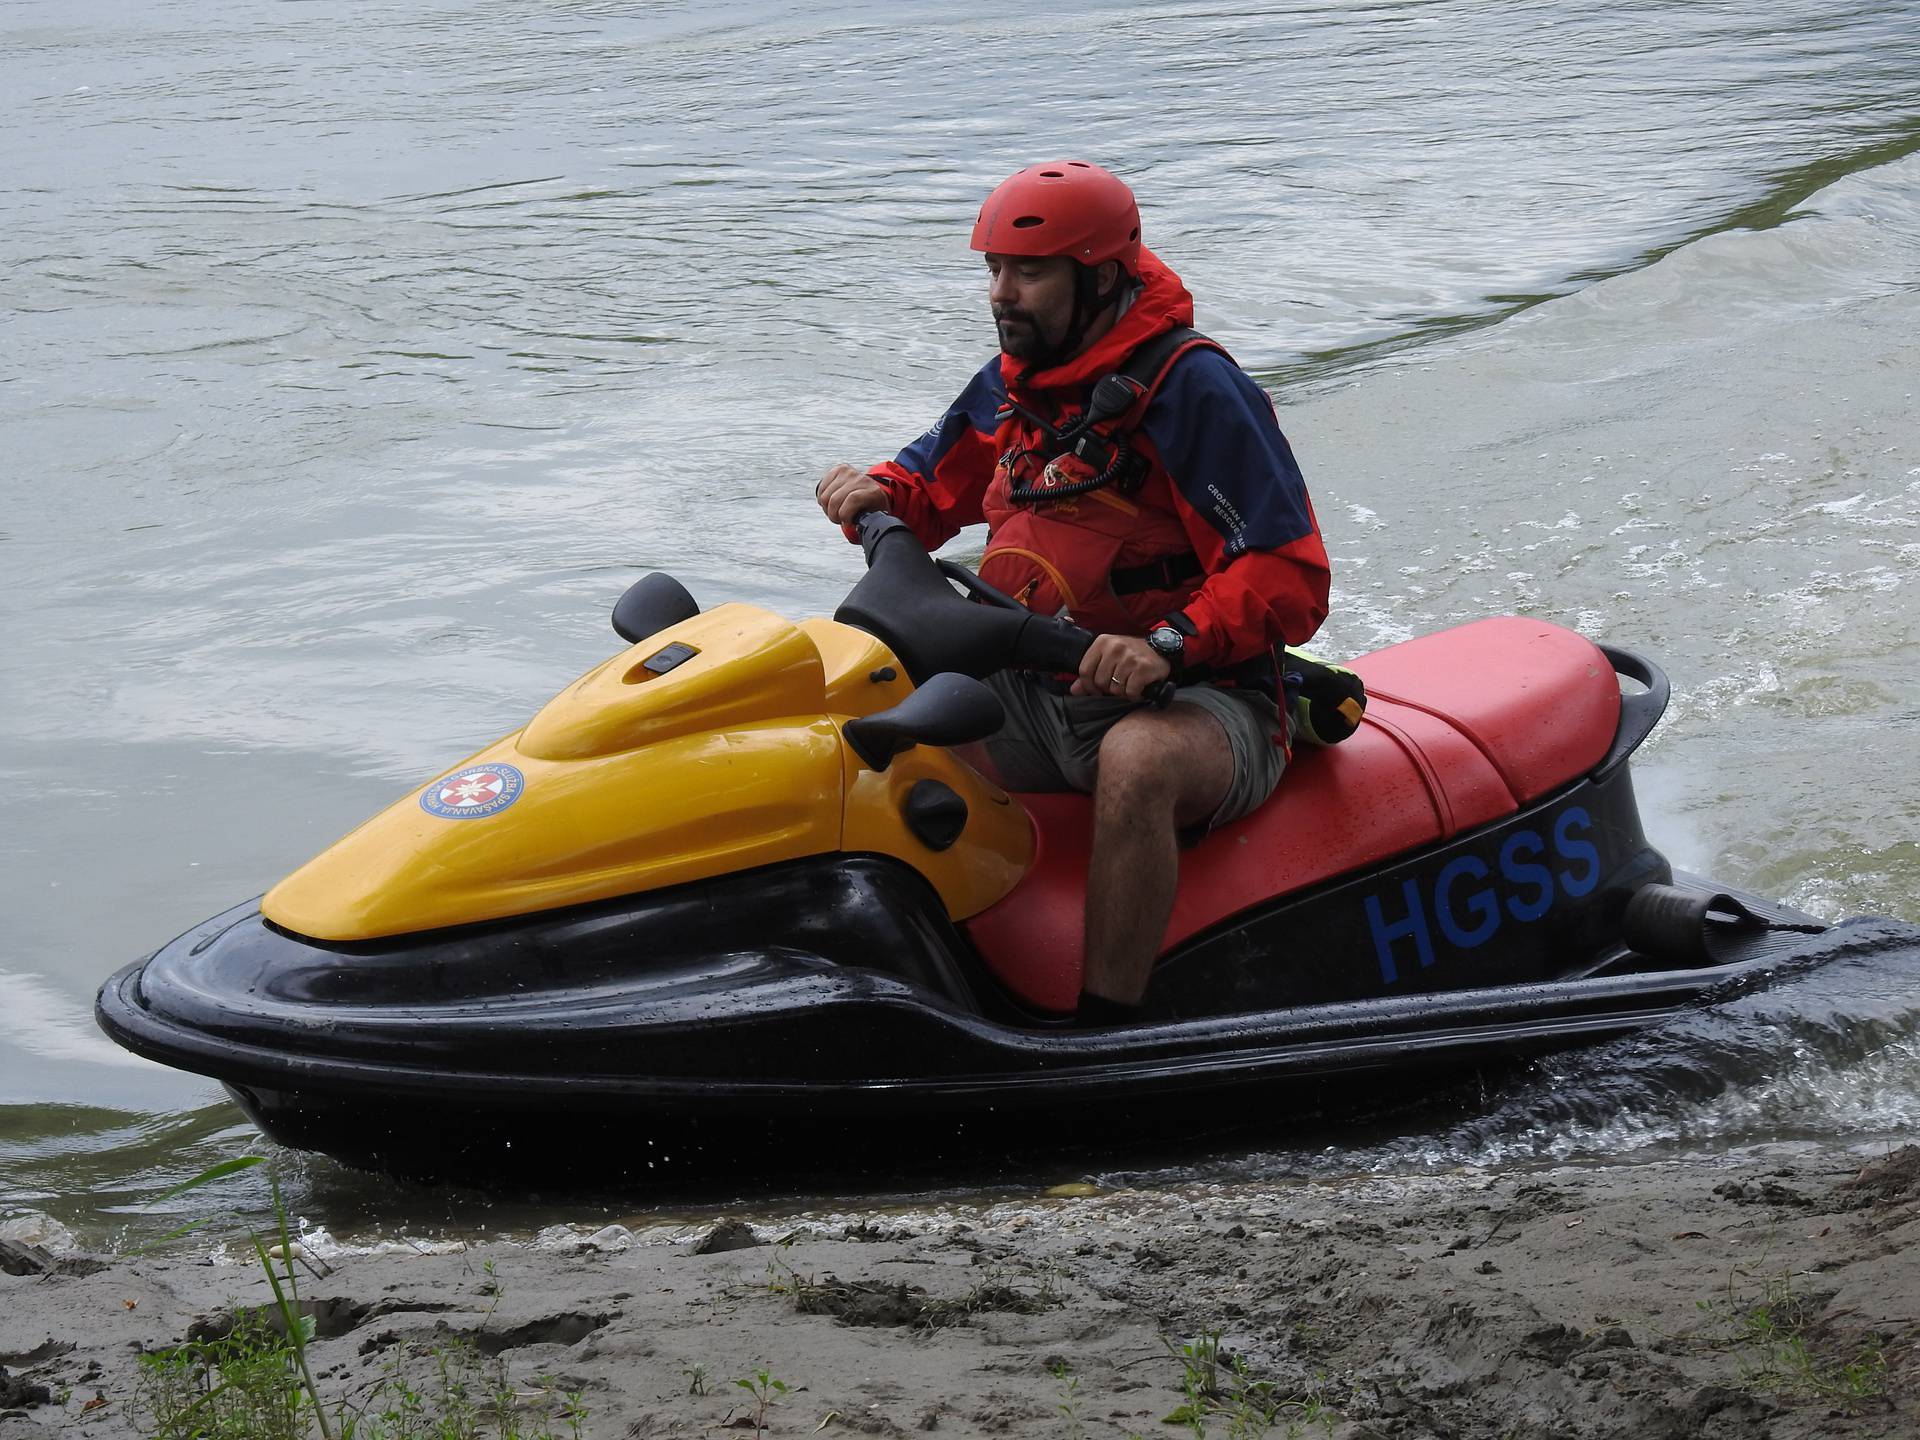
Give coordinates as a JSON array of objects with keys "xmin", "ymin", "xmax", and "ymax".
[{"xmin": 1140, "ymin": 349, "xmax": 1313, "ymax": 557}]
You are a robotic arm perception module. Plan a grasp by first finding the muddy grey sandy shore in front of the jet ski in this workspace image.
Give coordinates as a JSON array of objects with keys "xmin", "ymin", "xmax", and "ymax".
[{"xmin": 0, "ymin": 1146, "xmax": 1920, "ymax": 1440}]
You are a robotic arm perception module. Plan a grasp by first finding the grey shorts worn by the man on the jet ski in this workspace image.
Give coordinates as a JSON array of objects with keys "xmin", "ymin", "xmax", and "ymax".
[{"xmin": 987, "ymin": 670, "xmax": 1286, "ymax": 833}]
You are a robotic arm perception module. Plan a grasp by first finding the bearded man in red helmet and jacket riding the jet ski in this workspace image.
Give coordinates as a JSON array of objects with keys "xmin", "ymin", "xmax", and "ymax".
[{"xmin": 816, "ymin": 161, "xmax": 1329, "ymax": 1023}]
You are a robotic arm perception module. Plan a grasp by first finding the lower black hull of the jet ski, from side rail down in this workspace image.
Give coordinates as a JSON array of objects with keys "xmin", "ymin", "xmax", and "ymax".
[{"xmin": 100, "ymin": 913, "xmax": 1916, "ymax": 1185}]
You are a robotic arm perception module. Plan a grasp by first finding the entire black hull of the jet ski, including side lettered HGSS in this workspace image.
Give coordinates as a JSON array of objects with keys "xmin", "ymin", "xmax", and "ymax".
[{"xmin": 98, "ymin": 744, "xmax": 1910, "ymax": 1183}]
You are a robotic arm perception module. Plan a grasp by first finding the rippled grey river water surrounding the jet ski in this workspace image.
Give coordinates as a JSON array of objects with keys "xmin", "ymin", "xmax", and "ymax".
[{"xmin": 11, "ymin": 0, "xmax": 1920, "ymax": 1235}]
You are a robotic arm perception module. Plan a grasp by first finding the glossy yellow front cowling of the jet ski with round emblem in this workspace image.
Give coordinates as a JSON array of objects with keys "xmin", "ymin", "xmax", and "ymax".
[{"xmin": 261, "ymin": 605, "xmax": 1033, "ymax": 941}]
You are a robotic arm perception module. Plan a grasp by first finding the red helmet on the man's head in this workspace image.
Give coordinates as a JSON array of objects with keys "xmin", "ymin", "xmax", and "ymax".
[{"xmin": 972, "ymin": 159, "xmax": 1140, "ymax": 275}]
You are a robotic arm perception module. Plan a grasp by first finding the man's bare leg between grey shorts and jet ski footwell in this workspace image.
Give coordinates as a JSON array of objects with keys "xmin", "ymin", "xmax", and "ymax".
[{"xmin": 1081, "ymin": 705, "xmax": 1233, "ymax": 1004}]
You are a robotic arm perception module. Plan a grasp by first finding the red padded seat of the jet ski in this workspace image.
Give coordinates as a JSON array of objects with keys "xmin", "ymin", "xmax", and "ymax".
[{"xmin": 966, "ymin": 616, "xmax": 1620, "ymax": 1012}]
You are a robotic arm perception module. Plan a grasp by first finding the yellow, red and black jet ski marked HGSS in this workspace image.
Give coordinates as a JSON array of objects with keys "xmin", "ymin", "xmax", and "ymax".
[{"xmin": 96, "ymin": 515, "xmax": 1907, "ymax": 1179}]
